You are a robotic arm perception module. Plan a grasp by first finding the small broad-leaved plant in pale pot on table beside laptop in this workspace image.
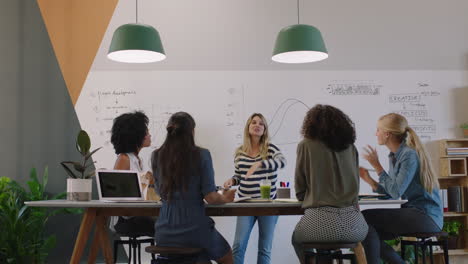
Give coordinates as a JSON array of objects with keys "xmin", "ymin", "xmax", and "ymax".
[{"xmin": 60, "ymin": 130, "xmax": 101, "ymax": 201}]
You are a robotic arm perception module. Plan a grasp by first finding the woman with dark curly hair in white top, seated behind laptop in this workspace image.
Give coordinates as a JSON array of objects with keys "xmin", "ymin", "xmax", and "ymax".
[{"xmin": 111, "ymin": 112, "xmax": 154, "ymax": 236}]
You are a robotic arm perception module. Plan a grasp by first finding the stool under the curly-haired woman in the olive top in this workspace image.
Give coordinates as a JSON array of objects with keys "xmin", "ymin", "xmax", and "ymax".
[{"xmin": 302, "ymin": 243, "xmax": 358, "ymax": 264}]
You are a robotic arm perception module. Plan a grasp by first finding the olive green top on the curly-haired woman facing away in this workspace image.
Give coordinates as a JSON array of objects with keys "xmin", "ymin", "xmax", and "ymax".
[{"xmin": 294, "ymin": 139, "xmax": 359, "ymax": 208}]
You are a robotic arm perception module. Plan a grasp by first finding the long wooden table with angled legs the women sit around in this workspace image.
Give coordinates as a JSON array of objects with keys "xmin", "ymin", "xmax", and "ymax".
[{"xmin": 25, "ymin": 200, "xmax": 406, "ymax": 264}]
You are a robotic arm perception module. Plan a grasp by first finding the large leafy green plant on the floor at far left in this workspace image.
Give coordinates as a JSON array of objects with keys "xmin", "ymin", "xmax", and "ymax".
[{"xmin": 0, "ymin": 167, "xmax": 82, "ymax": 264}]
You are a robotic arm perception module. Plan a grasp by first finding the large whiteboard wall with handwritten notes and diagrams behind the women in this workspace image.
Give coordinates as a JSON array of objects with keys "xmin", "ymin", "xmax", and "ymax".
[{"xmin": 75, "ymin": 71, "xmax": 468, "ymax": 263}]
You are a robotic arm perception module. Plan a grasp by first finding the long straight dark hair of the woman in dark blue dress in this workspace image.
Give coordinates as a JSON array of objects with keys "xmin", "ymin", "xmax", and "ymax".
[{"xmin": 151, "ymin": 112, "xmax": 201, "ymax": 200}]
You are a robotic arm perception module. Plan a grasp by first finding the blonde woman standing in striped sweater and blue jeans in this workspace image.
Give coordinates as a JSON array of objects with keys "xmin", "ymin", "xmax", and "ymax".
[{"xmin": 224, "ymin": 113, "xmax": 286, "ymax": 264}]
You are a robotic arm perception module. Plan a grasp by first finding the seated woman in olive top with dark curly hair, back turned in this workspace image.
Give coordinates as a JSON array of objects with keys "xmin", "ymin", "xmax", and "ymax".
[{"xmin": 292, "ymin": 104, "xmax": 368, "ymax": 263}]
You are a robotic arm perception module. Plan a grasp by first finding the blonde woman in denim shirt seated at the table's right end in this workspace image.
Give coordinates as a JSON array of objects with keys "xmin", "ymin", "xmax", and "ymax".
[{"xmin": 360, "ymin": 113, "xmax": 443, "ymax": 264}]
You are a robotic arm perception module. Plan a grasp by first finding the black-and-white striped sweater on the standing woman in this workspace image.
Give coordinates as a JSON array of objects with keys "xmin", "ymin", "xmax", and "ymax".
[{"xmin": 232, "ymin": 143, "xmax": 286, "ymax": 199}]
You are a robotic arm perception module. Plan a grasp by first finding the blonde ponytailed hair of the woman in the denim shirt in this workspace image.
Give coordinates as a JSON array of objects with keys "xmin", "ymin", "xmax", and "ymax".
[{"xmin": 378, "ymin": 113, "xmax": 439, "ymax": 193}]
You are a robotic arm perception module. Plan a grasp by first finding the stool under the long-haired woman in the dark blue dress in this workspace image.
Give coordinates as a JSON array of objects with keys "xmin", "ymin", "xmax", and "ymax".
[{"xmin": 145, "ymin": 246, "xmax": 203, "ymax": 264}]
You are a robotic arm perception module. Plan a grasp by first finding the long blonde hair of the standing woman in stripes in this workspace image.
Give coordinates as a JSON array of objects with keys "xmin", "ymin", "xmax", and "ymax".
[{"xmin": 234, "ymin": 113, "xmax": 270, "ymax": 159}]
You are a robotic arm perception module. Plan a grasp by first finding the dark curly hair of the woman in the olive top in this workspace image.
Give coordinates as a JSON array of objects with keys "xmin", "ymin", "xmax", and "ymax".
[{"xmin": 301, "ymin": 104, "xmax": 356, "ymax": 151}]
